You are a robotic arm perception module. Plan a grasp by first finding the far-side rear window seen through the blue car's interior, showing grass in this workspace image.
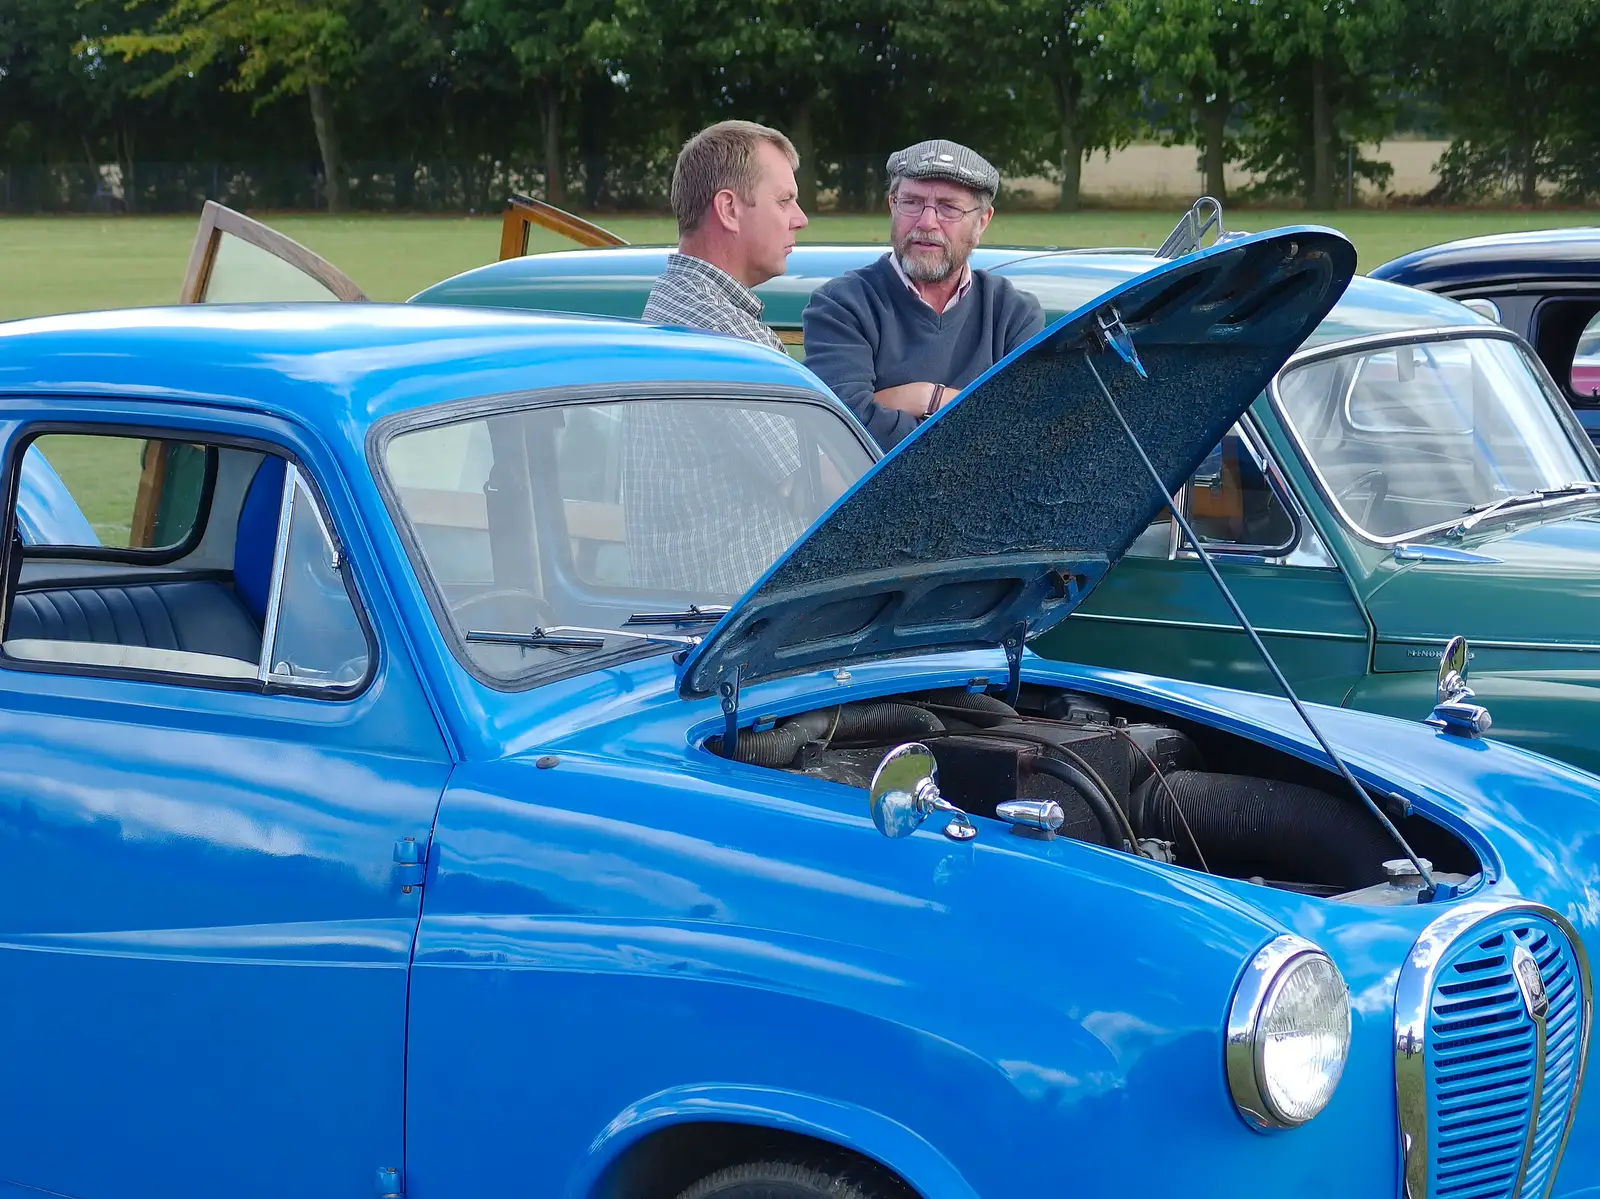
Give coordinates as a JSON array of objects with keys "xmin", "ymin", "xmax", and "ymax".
[{"xmin": 24, "ymin": 434, "xmax": 214, "ymax": 552}]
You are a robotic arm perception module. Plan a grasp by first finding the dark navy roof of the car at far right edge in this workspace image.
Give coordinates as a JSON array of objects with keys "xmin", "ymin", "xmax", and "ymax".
[{"xmin": 1373, "ymin": 226, "xmax": 1600, "ymax": 290}]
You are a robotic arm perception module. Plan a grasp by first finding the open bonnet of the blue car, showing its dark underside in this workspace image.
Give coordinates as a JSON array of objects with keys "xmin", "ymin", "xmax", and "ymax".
[{"xmin": 678, "ymin": 227, "xmax": 1355, "ymax": 706}]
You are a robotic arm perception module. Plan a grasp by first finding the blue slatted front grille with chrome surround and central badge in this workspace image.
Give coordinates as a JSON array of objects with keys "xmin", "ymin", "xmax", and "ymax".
[{"xmin": 1395, "ymin": 904, "xmax": 1592, "ymax": 1199}]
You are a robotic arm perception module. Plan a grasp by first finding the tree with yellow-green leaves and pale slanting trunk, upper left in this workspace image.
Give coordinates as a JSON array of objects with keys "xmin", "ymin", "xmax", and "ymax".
[{"xmin": 102, "ymin": 0, "xmax": 360, "ymax": 213}]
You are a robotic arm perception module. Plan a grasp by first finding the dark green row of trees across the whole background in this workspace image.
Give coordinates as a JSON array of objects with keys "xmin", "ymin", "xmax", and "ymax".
[{"xmin": 9, "ymin": 0, "xmax": 1600, "ymax": 208}]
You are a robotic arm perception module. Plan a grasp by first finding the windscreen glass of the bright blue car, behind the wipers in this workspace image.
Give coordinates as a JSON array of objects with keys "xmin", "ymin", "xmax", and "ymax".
[{"xmin": 382, "ymin": 397, "xmax": 872, "ymax": 676}]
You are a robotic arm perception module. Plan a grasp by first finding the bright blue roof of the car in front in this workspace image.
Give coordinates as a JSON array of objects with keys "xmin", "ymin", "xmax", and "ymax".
[{"xmin": 0, "ymin": 303, "xmax": 843, "ymax": 427}]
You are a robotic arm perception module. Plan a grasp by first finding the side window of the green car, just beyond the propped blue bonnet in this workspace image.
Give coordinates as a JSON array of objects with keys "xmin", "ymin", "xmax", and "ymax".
[{"xmin": 1128, "ymin": 424, "xmax": 1294, "ymax": 557}]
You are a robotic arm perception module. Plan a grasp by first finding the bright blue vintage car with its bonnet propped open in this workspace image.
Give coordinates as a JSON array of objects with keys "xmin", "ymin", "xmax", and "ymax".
[{"xmin": 0, "ymin": 229, "xmax": 1600, "ymax": 1199}]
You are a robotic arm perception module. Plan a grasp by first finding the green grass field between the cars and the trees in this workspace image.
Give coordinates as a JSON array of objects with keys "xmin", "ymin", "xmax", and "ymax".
[{"xmin": 0, "ymin": 208, "xmax": 1595, "ymax": 320}]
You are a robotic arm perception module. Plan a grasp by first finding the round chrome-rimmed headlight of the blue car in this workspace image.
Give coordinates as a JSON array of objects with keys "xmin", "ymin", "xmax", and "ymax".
[{"xmin": 1227, "ymin": 936, "xmax": 1350, "ymax": 1129}]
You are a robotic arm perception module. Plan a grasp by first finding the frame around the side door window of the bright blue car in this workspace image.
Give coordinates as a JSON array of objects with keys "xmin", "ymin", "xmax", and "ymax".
[{"xmin": 0, "ymin": 416, "xmax": 382, "ymax": 703}]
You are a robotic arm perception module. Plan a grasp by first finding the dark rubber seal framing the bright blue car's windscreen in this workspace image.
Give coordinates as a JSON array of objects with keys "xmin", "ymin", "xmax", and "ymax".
[{"xmin": 366, "ymin": 381, "xmax": 883, "ymax": 693}]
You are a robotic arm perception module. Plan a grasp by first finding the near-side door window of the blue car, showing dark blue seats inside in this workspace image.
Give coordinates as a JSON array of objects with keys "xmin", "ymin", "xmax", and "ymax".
[{"xmin": 0, "ymin": 432, "xmax": 371, "ymax": 695}]
